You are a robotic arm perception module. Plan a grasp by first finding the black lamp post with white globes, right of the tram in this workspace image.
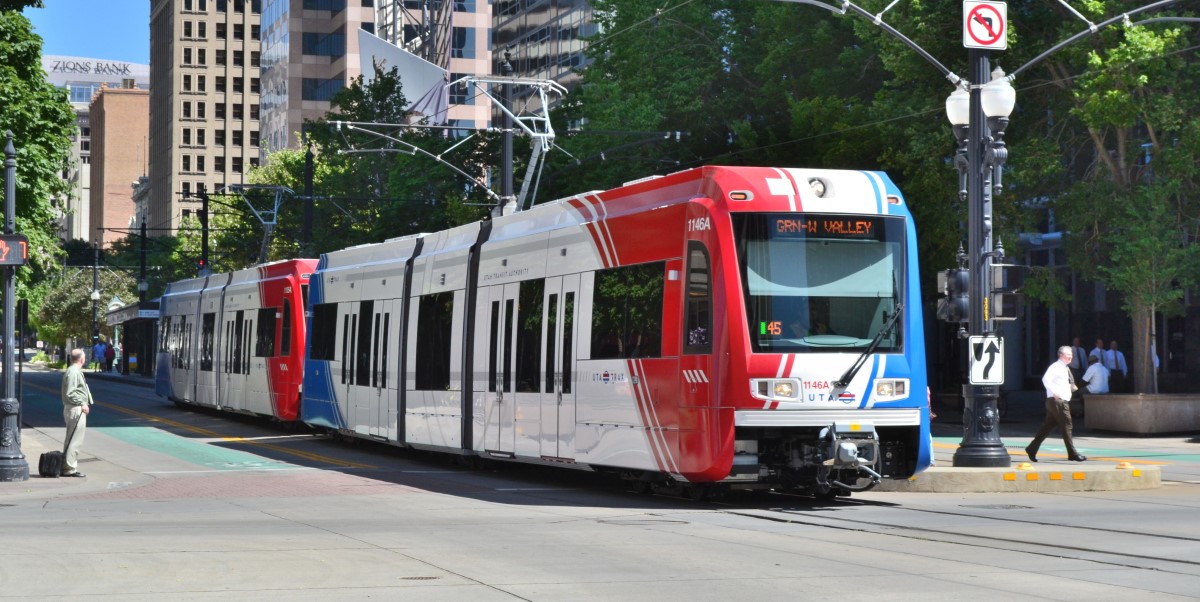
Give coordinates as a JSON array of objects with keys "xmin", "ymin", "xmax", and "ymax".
[{"xmin": 946, "ymin": 49, "xmax": 1016, "ymax": 466}]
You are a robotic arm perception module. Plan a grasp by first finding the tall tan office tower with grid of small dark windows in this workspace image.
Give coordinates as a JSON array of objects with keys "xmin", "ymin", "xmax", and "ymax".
[{"xmin": 148, "ymin": 0, "xmax": 262, "ymax": 235}]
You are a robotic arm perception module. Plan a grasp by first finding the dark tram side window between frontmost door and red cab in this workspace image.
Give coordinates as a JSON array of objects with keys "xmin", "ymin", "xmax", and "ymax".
[{"xmin": 592, "ymin": 261, "xmax": 666, "ymax": 360}]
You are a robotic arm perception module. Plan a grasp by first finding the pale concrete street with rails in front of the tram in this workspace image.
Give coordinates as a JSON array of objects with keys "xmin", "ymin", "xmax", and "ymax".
[{"xmin": 0, "ymin": 372, "xmax": 1200, "ymax": 601}]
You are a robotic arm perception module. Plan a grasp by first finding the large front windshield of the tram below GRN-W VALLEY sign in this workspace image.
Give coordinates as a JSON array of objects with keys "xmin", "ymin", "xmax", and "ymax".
[{"xmin": 732, "ymin": 213, "xmax": 905, "ymax": 353}]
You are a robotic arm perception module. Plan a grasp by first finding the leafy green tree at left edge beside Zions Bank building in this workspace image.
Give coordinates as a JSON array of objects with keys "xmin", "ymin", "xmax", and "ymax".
[{"xmin": 0, "ymin": 0, "xmax": 76, "ymax": 289}]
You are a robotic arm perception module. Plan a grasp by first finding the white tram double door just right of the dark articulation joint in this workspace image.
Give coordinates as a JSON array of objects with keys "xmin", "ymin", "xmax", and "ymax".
[{"xmin": 476, "ymin": 283, "xmax": 521, "ymax": 453}]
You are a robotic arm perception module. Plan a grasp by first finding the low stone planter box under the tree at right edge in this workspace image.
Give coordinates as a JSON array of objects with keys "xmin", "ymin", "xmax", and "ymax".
[{"xmin": 1084, "ymin": 393, "xmax": 1200, "ymax": 435}]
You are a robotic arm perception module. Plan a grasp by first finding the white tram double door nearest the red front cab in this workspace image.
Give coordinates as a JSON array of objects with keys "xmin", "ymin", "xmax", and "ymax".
[{"xmin": 541, "ymin": 273, "xmax": 580, "ymax": 459}]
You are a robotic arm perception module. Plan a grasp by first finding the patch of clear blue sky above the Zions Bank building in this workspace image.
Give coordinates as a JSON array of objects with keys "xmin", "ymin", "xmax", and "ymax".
[{"xmin": 25, "ymin": 0, "xmax": 150, "ymax": 65}]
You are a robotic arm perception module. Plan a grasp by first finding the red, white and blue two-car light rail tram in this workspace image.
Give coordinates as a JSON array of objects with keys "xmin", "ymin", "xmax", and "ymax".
[{"xmin": 157, "ymin": 167, "xmax": 932, "ymax": 495}]
